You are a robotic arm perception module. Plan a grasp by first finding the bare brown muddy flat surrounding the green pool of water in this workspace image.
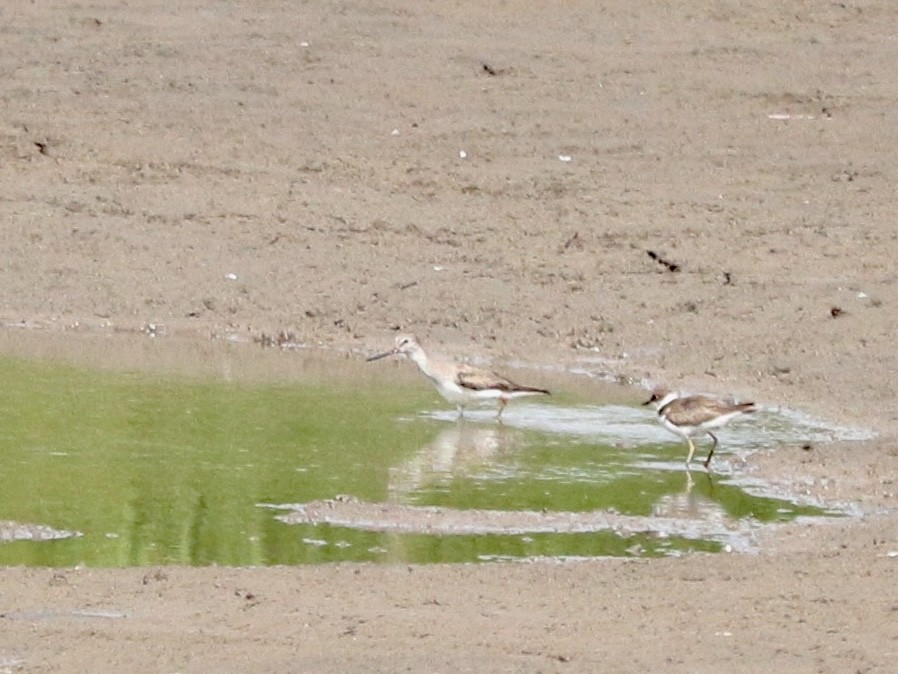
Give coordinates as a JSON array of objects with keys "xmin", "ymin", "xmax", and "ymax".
[{"xmin": 0, "ymin": 0, "xmax": 898, "ymax": 672}]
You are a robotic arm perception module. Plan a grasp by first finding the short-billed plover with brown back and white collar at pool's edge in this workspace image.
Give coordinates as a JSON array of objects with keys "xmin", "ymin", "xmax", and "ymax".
[{"xmin": 643, "ymin": 389, "xmax": 756, "ymax": 469}]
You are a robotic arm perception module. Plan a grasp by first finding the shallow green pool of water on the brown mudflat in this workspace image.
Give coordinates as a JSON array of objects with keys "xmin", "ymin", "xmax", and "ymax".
[{"xmin": 0, "ymin": 338, "xmax": 840, "ymax": 567}]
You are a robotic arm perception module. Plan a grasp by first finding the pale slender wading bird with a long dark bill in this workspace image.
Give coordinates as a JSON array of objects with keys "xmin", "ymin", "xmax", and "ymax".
[{"xmin": 368, "ymin": 335, "xmax": 549, "ymax": 419}]
